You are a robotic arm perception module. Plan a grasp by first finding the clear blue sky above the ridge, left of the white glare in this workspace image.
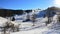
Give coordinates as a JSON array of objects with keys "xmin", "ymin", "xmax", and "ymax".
[{"xmin": 0, "ymin": 0, "xmax": 53, "ymax": 9}]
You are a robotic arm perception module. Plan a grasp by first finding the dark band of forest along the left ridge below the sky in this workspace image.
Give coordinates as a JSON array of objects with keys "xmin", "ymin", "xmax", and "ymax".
[{"xmin": 0, "ymin": 9, "xmax": 32, "ymax": 17}]
